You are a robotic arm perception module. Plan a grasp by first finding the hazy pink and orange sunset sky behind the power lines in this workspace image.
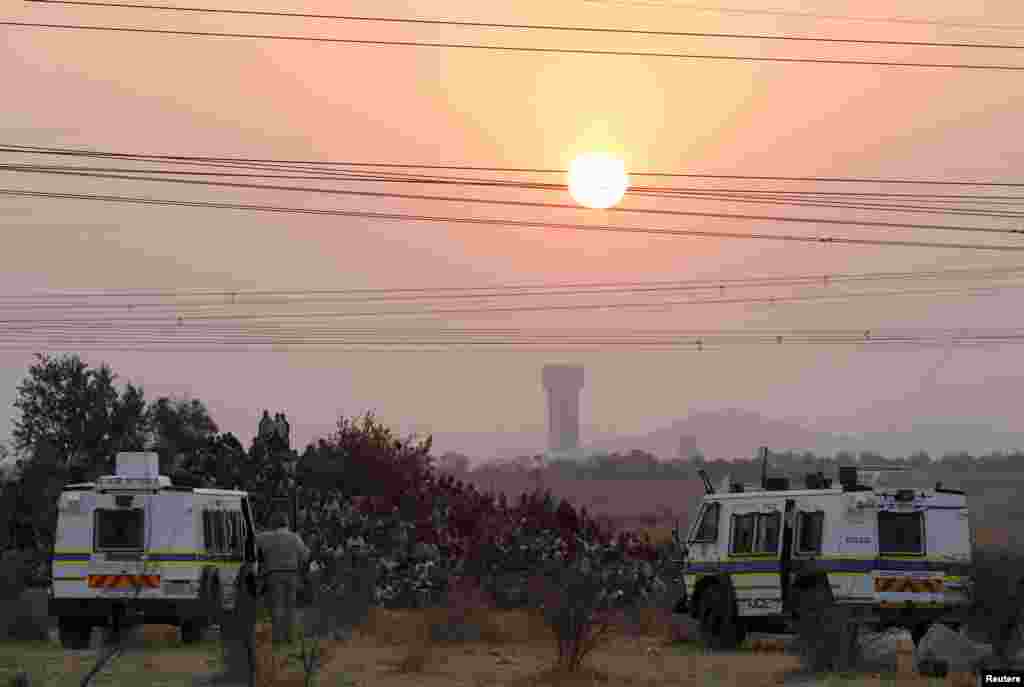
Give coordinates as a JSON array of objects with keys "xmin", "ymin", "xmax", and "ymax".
[{"xmin": 0, "ymin": 0, "xmax": 1024, "ymax": 462}]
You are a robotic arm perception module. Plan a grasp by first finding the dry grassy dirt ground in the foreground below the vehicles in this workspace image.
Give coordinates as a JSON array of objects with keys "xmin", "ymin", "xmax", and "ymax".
[{"xmin": 0, "ymin": 611, "xmax": 958, "ymax": 687}]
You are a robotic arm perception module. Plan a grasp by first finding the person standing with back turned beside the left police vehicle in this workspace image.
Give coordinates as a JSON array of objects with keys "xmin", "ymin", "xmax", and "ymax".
[{"xmin": 256, "ymin": 512, "xmax": 309, "ymax": 643}]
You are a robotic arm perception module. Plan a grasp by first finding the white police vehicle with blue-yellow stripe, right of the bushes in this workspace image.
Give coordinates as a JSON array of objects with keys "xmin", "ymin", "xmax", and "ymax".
[{"xmin": 674, "ymin": 467, "xmax": 972, "ymax": 648}]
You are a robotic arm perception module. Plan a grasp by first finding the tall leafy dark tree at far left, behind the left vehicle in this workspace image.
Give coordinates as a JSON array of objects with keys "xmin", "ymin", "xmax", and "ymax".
[{"xmin": 12, "ymin": 353, "xmax": 145, "ymax": 478}]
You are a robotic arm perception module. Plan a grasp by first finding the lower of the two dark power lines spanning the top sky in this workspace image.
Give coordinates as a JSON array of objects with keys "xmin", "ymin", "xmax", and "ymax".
[{"xmin": 6, "ymin": 22, "xmax": 1024, "ymax": 72}]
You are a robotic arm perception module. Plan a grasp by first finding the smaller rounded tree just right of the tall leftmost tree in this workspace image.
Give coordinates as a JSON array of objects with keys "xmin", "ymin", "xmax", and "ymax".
[{"xmin": 145, "ymin": 396, "xmax": 218, "ymax": 474}]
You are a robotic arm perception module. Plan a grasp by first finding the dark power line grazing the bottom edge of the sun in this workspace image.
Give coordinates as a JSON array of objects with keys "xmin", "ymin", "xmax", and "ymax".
[{"xmin": 0, "ymin": 164, "xmax": 1024, "ymax": 234}]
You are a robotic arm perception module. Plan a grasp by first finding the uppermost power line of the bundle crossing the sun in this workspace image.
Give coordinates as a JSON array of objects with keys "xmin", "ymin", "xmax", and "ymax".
[{"xmin": 6, "ymin": 143, "xmax": 1024, "ymax": 185}]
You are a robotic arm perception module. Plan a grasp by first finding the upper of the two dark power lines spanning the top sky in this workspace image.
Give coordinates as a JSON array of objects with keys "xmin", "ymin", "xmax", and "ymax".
[{"xmin": 27, "ymin": 0, "xmax": 1024, "ymax": 50}]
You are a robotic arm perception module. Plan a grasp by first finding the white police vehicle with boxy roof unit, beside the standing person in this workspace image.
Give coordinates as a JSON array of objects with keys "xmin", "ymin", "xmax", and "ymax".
[{"xmin": 49, "ymin": 453, "xmax": 256, "ymax": 648}]
